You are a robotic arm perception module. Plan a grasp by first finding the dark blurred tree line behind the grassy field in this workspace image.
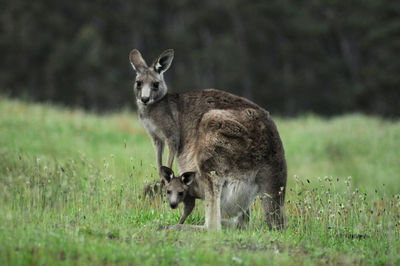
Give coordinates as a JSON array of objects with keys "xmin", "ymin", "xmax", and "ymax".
[{"xmin": 0, "ymin": 0, "xmax": 400, "ymax": 117}]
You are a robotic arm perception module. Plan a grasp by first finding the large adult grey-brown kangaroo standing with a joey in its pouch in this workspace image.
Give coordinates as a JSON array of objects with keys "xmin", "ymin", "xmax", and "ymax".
[{"xmin": 129, "ymin": 49, "xmax": 287, "ymax": 230}]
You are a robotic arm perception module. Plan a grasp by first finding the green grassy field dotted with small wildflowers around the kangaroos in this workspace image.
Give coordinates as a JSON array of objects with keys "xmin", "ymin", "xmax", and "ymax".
[{"xmin": 0, "ymin": 98, "xmax": 400, "ymax": 265}]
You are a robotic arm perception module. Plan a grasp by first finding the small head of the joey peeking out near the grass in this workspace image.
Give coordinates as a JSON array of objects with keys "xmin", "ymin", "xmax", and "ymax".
[{"xmin": 161, "ymin": 166, "xmax": 195, "ymax": 209}]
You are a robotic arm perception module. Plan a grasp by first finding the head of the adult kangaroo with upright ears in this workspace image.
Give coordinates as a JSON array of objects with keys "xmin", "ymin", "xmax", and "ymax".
[{"xmin": 129, "ymin": 49, "xmax": 174, "ymax": 106}]
